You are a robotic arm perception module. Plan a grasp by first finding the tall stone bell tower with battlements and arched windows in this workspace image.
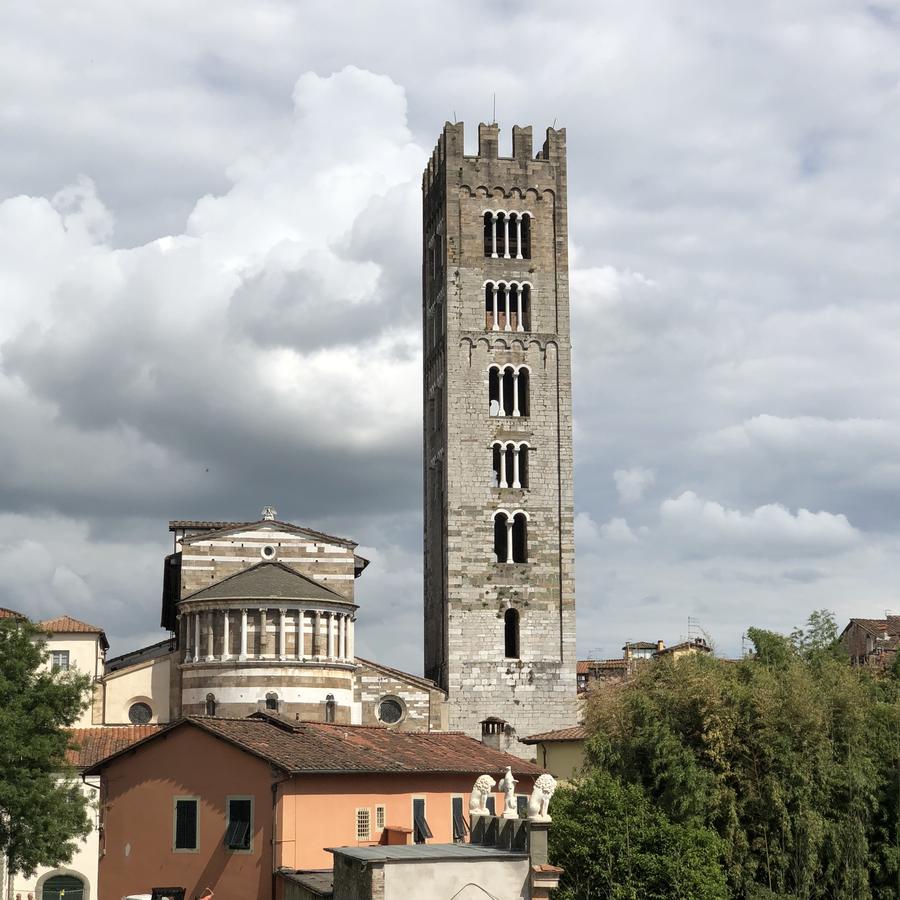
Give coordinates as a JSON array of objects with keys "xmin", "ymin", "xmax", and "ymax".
[{"xmin": 422, "ymin": 122, "xmax": 575, "ymax": 756}]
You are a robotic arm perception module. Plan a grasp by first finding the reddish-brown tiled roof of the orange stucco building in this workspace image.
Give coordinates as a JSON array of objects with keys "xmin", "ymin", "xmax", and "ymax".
[{"xmin": 88, "ymin": 714, "xmax": 544, "ymax": 776}]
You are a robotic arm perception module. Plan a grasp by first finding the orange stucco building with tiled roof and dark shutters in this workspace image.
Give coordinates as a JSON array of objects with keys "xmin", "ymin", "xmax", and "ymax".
[{"xmin": 90, "ymin": 713, "xmax": 542, "ymax": 900}]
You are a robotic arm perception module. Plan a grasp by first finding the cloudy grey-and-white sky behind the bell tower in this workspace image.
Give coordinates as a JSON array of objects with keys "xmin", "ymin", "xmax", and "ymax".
[{"xmin": 0, "ymin": 0, "xmax": 900, "ymax": 671}]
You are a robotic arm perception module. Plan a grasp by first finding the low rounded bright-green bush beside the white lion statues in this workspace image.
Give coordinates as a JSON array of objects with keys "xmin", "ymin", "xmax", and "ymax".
[{"xmin": 549, "ymin": 770, "xmax": 726, "ymax": 900}]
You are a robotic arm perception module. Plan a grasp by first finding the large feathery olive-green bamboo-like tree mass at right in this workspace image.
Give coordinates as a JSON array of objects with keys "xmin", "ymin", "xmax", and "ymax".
[{"xmin": 576, "ymin": 612, "xmax": 900, "ymax": 900}]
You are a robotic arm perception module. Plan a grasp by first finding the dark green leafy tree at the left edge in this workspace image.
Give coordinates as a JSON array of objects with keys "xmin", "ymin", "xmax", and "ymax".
[{"xmin": 0, "ymin": 619, "xmax": 90, "ymax": 875}]
